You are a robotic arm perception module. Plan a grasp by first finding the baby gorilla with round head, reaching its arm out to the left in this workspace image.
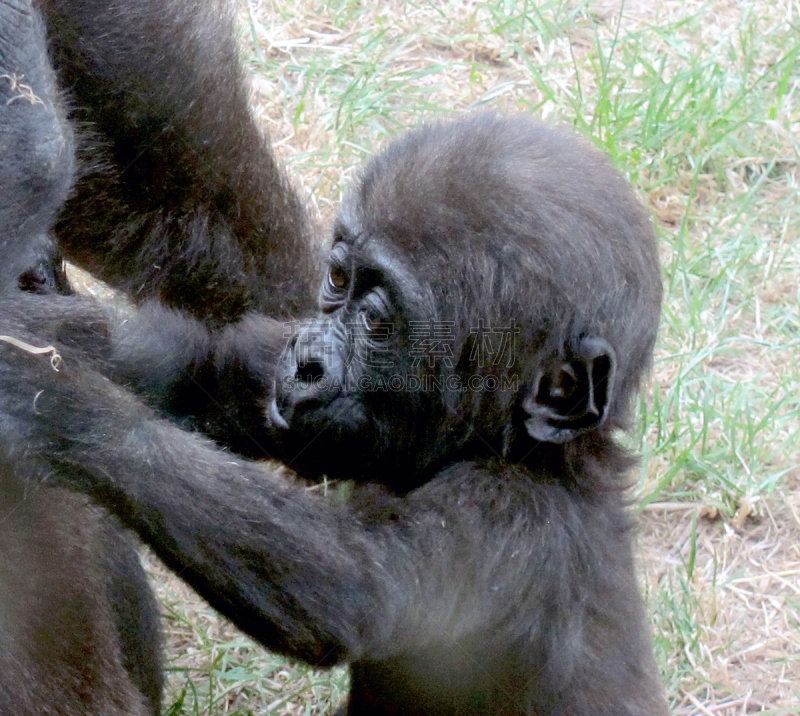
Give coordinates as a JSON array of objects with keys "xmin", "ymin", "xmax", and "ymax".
[{"xmin": 0, "ymin": 115, "xmax": 667, "ymax": 716}]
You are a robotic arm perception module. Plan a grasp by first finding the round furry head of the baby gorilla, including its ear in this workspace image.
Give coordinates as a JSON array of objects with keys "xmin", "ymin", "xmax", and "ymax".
[{"xmin": 271, "ymin": 115, "xmax": 661, "ymax": 491}]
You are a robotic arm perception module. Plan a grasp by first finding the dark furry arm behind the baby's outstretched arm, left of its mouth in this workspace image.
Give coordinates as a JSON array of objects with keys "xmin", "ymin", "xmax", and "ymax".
[{"xmin": 0, "ymin": 295, "xmax": 286, "ymax": 458}]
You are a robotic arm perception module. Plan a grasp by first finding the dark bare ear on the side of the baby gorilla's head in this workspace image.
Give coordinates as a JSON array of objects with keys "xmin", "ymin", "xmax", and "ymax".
[{"xmin": 522, "ymin": 336, "xmax": 617, "ymax": 443}]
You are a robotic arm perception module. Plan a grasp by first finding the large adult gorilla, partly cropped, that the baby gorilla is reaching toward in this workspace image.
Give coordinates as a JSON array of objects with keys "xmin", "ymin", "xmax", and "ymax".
[{"xmin": 0, "ymin": 0, "xmax": 314, "ymax": 716}]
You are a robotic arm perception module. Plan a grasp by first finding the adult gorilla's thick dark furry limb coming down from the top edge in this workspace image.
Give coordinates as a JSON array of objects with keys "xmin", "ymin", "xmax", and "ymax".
[{"xmin": 45, "ymin": 0, "xmax": 315, "ymax": 325}]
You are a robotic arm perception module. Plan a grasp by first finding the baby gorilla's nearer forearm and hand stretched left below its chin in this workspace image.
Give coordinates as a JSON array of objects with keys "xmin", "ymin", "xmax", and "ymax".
[{"xmin": 0, "ymin": 334, "xmax": 528, "ymax": 664}]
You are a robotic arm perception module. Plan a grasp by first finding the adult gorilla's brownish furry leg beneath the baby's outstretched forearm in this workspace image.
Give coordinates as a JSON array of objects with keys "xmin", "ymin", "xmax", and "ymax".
[{"xmin": 0, "ymin": 465, "xmax": 161, "ymax": 716}]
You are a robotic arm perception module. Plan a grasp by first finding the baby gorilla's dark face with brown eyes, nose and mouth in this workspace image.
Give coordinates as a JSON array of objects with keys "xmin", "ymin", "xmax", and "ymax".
[{"xmin": 270, "ymin": 232, "xmax": 444, "ymax": 484}]
